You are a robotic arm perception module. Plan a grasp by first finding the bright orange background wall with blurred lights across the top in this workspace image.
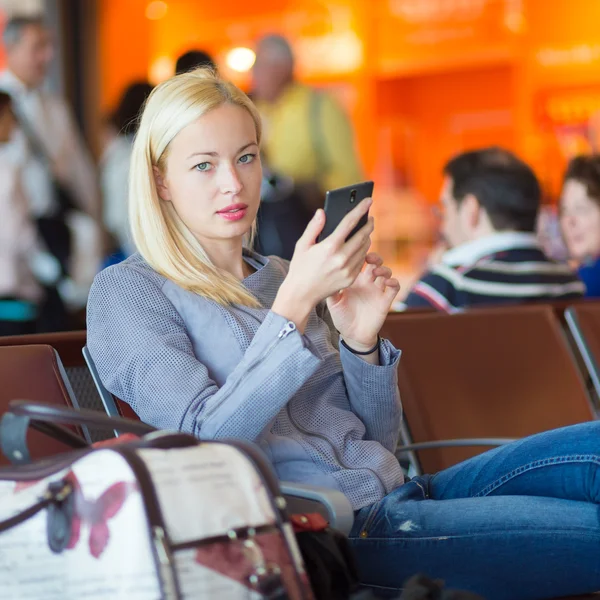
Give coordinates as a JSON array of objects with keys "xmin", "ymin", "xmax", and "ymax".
[{"xmin": 99, "ymin": 0, "xmax": 600, "ymax": 202}]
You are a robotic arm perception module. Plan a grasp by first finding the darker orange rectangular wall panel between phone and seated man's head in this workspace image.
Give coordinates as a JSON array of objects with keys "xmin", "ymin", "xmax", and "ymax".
[{"xmin": 376, "ymin": 65, "xmax": 516, "ymax": 202}]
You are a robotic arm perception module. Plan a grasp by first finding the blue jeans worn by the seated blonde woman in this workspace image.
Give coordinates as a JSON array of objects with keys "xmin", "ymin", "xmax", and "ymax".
[{"xmin": 350, "ymin": 421, "xmax": 600, "ymax": 600}]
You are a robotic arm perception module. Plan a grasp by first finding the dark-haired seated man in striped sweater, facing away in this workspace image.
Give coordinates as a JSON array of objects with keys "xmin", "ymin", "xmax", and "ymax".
[{"xmin": 402, "ymin": 148, "xmax": 584, "ymax": 312}]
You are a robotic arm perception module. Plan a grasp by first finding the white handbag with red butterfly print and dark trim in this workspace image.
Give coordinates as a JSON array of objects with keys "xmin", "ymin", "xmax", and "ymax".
[{"xmin": 0, "ymin": 401, "xmax": 313, "ymax": 600}]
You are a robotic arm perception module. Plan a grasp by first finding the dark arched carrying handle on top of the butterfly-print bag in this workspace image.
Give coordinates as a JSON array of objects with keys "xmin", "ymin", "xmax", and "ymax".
[{"xmin": 0, "ymin": 400, "xmax": 156, "ymax": 465}]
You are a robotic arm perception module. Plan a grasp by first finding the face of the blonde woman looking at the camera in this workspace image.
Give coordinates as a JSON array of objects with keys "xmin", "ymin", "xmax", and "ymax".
[{"xmin": 155, "ymin": 104, "xmax": 262, "ymax": 246}]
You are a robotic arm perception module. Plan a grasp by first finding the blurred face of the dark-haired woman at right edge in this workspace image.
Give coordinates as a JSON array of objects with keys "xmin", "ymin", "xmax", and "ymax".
[{"xmin": 560, "ymin": 179, "xmax": 600, "ymax": 261}]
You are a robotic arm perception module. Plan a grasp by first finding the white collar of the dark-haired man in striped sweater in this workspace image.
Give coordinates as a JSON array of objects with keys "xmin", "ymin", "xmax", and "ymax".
[{"xmin": 442, "ymin": 231, "xmax": 540, "ymax": 267}]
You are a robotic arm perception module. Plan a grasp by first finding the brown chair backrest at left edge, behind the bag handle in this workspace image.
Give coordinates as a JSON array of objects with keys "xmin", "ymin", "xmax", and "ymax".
[{"xmin": 0, "ymin": 344, "xmax": 90, "ymax": 465}]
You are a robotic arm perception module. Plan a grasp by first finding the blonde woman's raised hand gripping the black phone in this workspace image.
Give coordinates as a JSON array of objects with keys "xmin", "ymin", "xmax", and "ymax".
[{"xmin": 272, "ymin": 198, "xmax": 373, "ymax": 332}]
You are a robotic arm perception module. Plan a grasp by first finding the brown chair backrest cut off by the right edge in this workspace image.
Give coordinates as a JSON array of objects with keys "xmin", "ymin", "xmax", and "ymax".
[{"xmin": 565, "ymin": 302, "xmax": 600, "ymax": 404}]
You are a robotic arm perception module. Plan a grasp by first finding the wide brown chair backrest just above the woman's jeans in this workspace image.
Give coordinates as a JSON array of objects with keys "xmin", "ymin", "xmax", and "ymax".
[{"xmin": 382, "ymin": 306, "xmax": 596, "ymax": 472}]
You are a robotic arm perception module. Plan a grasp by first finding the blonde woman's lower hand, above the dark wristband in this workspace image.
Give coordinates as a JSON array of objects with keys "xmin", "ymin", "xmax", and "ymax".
[{"xmin": 327, "ymin": 253, "xmax": 400, "ymax": 352}]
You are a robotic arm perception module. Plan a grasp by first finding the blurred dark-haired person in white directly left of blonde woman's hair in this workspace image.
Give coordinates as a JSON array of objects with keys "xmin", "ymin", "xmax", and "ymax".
[{"xmin": 100, "ymin": 81, "xmax": 152, "ymax": 261}]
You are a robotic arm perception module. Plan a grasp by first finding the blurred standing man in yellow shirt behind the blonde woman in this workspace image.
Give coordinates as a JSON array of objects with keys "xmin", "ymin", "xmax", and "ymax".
[{"xmin": 251, "ymin": 35, "xmax": 363, "ymax": 260}]
